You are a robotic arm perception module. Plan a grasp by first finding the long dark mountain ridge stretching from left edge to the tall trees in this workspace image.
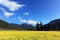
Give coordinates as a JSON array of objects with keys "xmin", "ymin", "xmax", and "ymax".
[{"xmin": 0, "ymin": 20, "xmax": 36, "ymax": 30}]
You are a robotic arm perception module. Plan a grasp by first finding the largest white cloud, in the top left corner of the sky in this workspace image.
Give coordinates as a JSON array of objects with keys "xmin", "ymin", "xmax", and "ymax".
[{"xmin": 0, "ymin": 0, "xmax": 25, "ymax": 11}]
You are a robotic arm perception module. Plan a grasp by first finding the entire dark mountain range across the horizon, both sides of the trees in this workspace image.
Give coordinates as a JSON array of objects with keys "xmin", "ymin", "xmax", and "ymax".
[{"xmin": 0, "ymin": 19, "xmax": 60, "ymax": 31}]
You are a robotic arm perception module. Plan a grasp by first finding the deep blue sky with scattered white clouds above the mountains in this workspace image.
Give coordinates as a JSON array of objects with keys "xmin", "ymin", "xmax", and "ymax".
[{"xmin": 0, "ymin": 0, "xmax": 60, "ymax": 24}]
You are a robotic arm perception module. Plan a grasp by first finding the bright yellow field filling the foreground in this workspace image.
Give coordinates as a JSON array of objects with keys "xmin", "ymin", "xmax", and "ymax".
[{"xmin": 0, "ymin": 31, "xmax": 60, "ymax": 40}]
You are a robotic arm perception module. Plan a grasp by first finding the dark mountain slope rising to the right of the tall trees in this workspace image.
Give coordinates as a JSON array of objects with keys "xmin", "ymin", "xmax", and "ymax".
[{"xmin": 40, "ymin": 19, "xmax": 60, "ymax": 31}]
